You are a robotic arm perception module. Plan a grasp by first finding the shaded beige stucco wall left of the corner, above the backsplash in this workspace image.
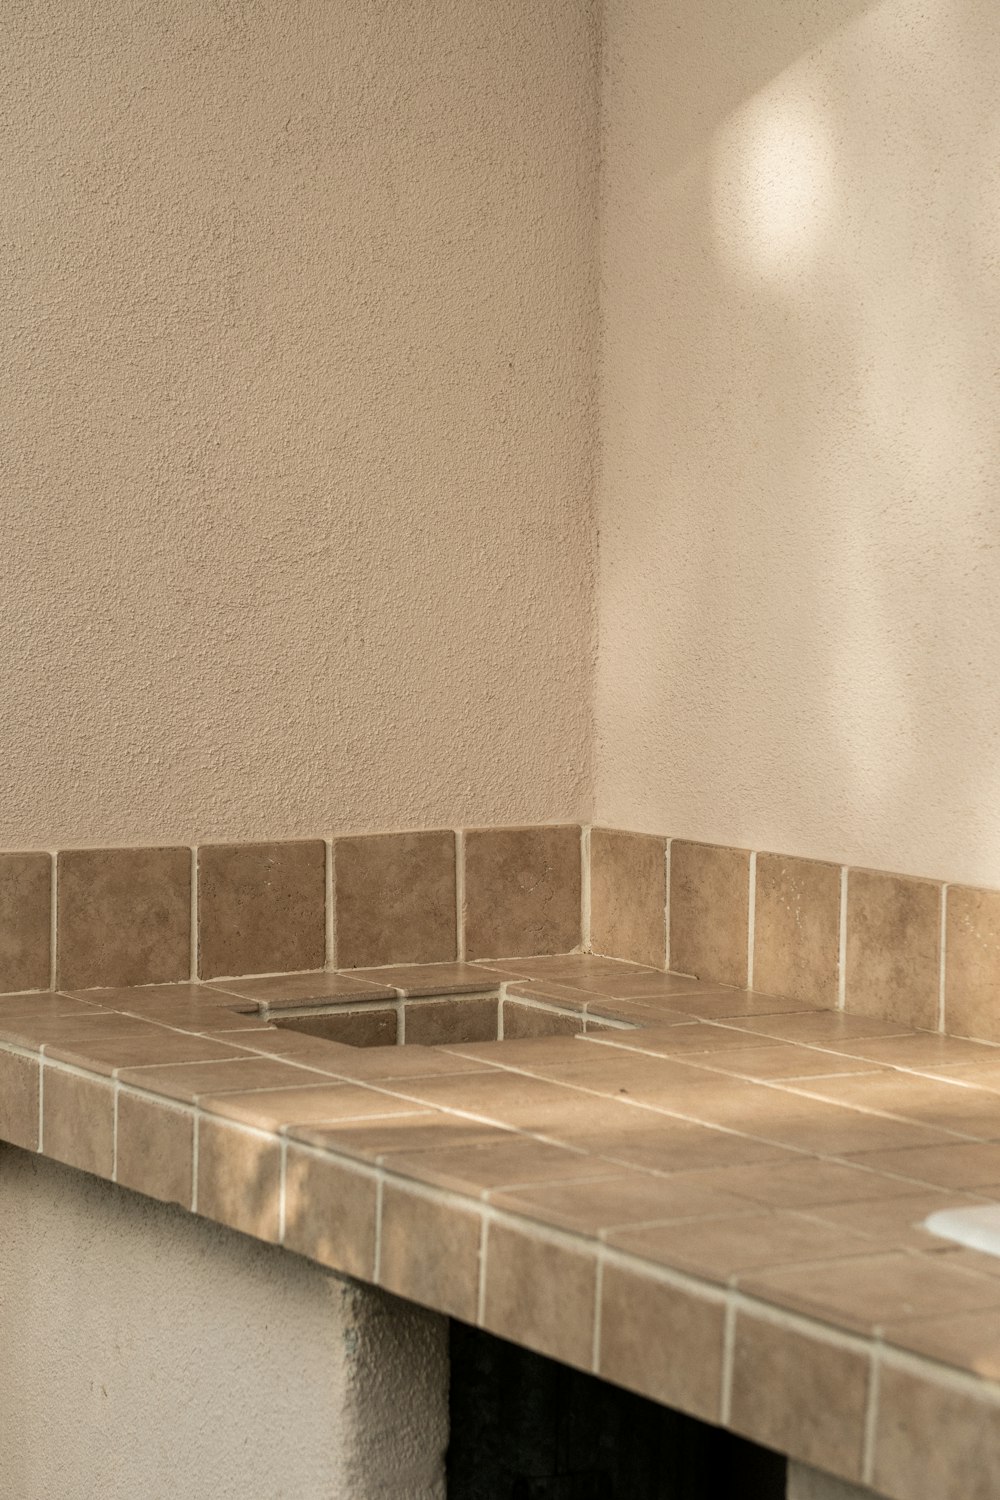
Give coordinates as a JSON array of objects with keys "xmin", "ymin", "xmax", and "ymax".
[{"xmin": 0, "ymin": 0, "xmax": 597, "ymax": 848}]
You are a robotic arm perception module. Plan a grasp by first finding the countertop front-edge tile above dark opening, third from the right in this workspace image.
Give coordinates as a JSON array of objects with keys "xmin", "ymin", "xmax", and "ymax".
[{"xmin": 598, "ymin": 1265, "xmax": 724, "ymax": 1422}]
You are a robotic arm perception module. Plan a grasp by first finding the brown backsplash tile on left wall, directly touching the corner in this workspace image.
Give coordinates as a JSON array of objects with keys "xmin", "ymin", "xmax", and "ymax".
[{"xmin": 463, "ymin": 824, "xmax": 580, "ymax": 960}]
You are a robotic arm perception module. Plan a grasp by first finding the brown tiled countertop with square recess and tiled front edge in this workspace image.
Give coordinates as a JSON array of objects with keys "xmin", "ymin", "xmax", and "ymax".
[{"xmin": 0, "ymin": 956, "xmax": 1000, "ymax": 1500}]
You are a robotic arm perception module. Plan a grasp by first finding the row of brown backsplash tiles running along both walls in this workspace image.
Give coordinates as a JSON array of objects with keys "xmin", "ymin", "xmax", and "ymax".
[{"xmin": 0, "ymin": 824, "xmax": 1000, "ymax": 1041}]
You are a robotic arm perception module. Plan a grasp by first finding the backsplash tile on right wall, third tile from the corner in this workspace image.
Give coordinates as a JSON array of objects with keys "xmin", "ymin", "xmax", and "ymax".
[{"xmin": 754, "ymin": 854, "xmax": 841, "ymax": 1007}]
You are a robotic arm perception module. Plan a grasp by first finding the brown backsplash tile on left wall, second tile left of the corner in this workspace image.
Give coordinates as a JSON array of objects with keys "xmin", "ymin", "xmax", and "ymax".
[{"xmin": 333, "ymin": 828, "xmax": 457, "ymax": 983}]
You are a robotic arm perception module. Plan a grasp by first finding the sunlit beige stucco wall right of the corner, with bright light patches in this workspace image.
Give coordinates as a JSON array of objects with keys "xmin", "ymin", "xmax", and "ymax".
[{"xmin": 595, "ymin": 0, "xmax": 1000, "ymax": 885}]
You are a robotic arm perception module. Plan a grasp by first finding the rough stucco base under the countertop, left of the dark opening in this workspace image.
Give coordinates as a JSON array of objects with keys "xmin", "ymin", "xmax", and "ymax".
[{"xmin": 0, "ymin": 1146, "xmax": 448, "ymax": 1500}]
